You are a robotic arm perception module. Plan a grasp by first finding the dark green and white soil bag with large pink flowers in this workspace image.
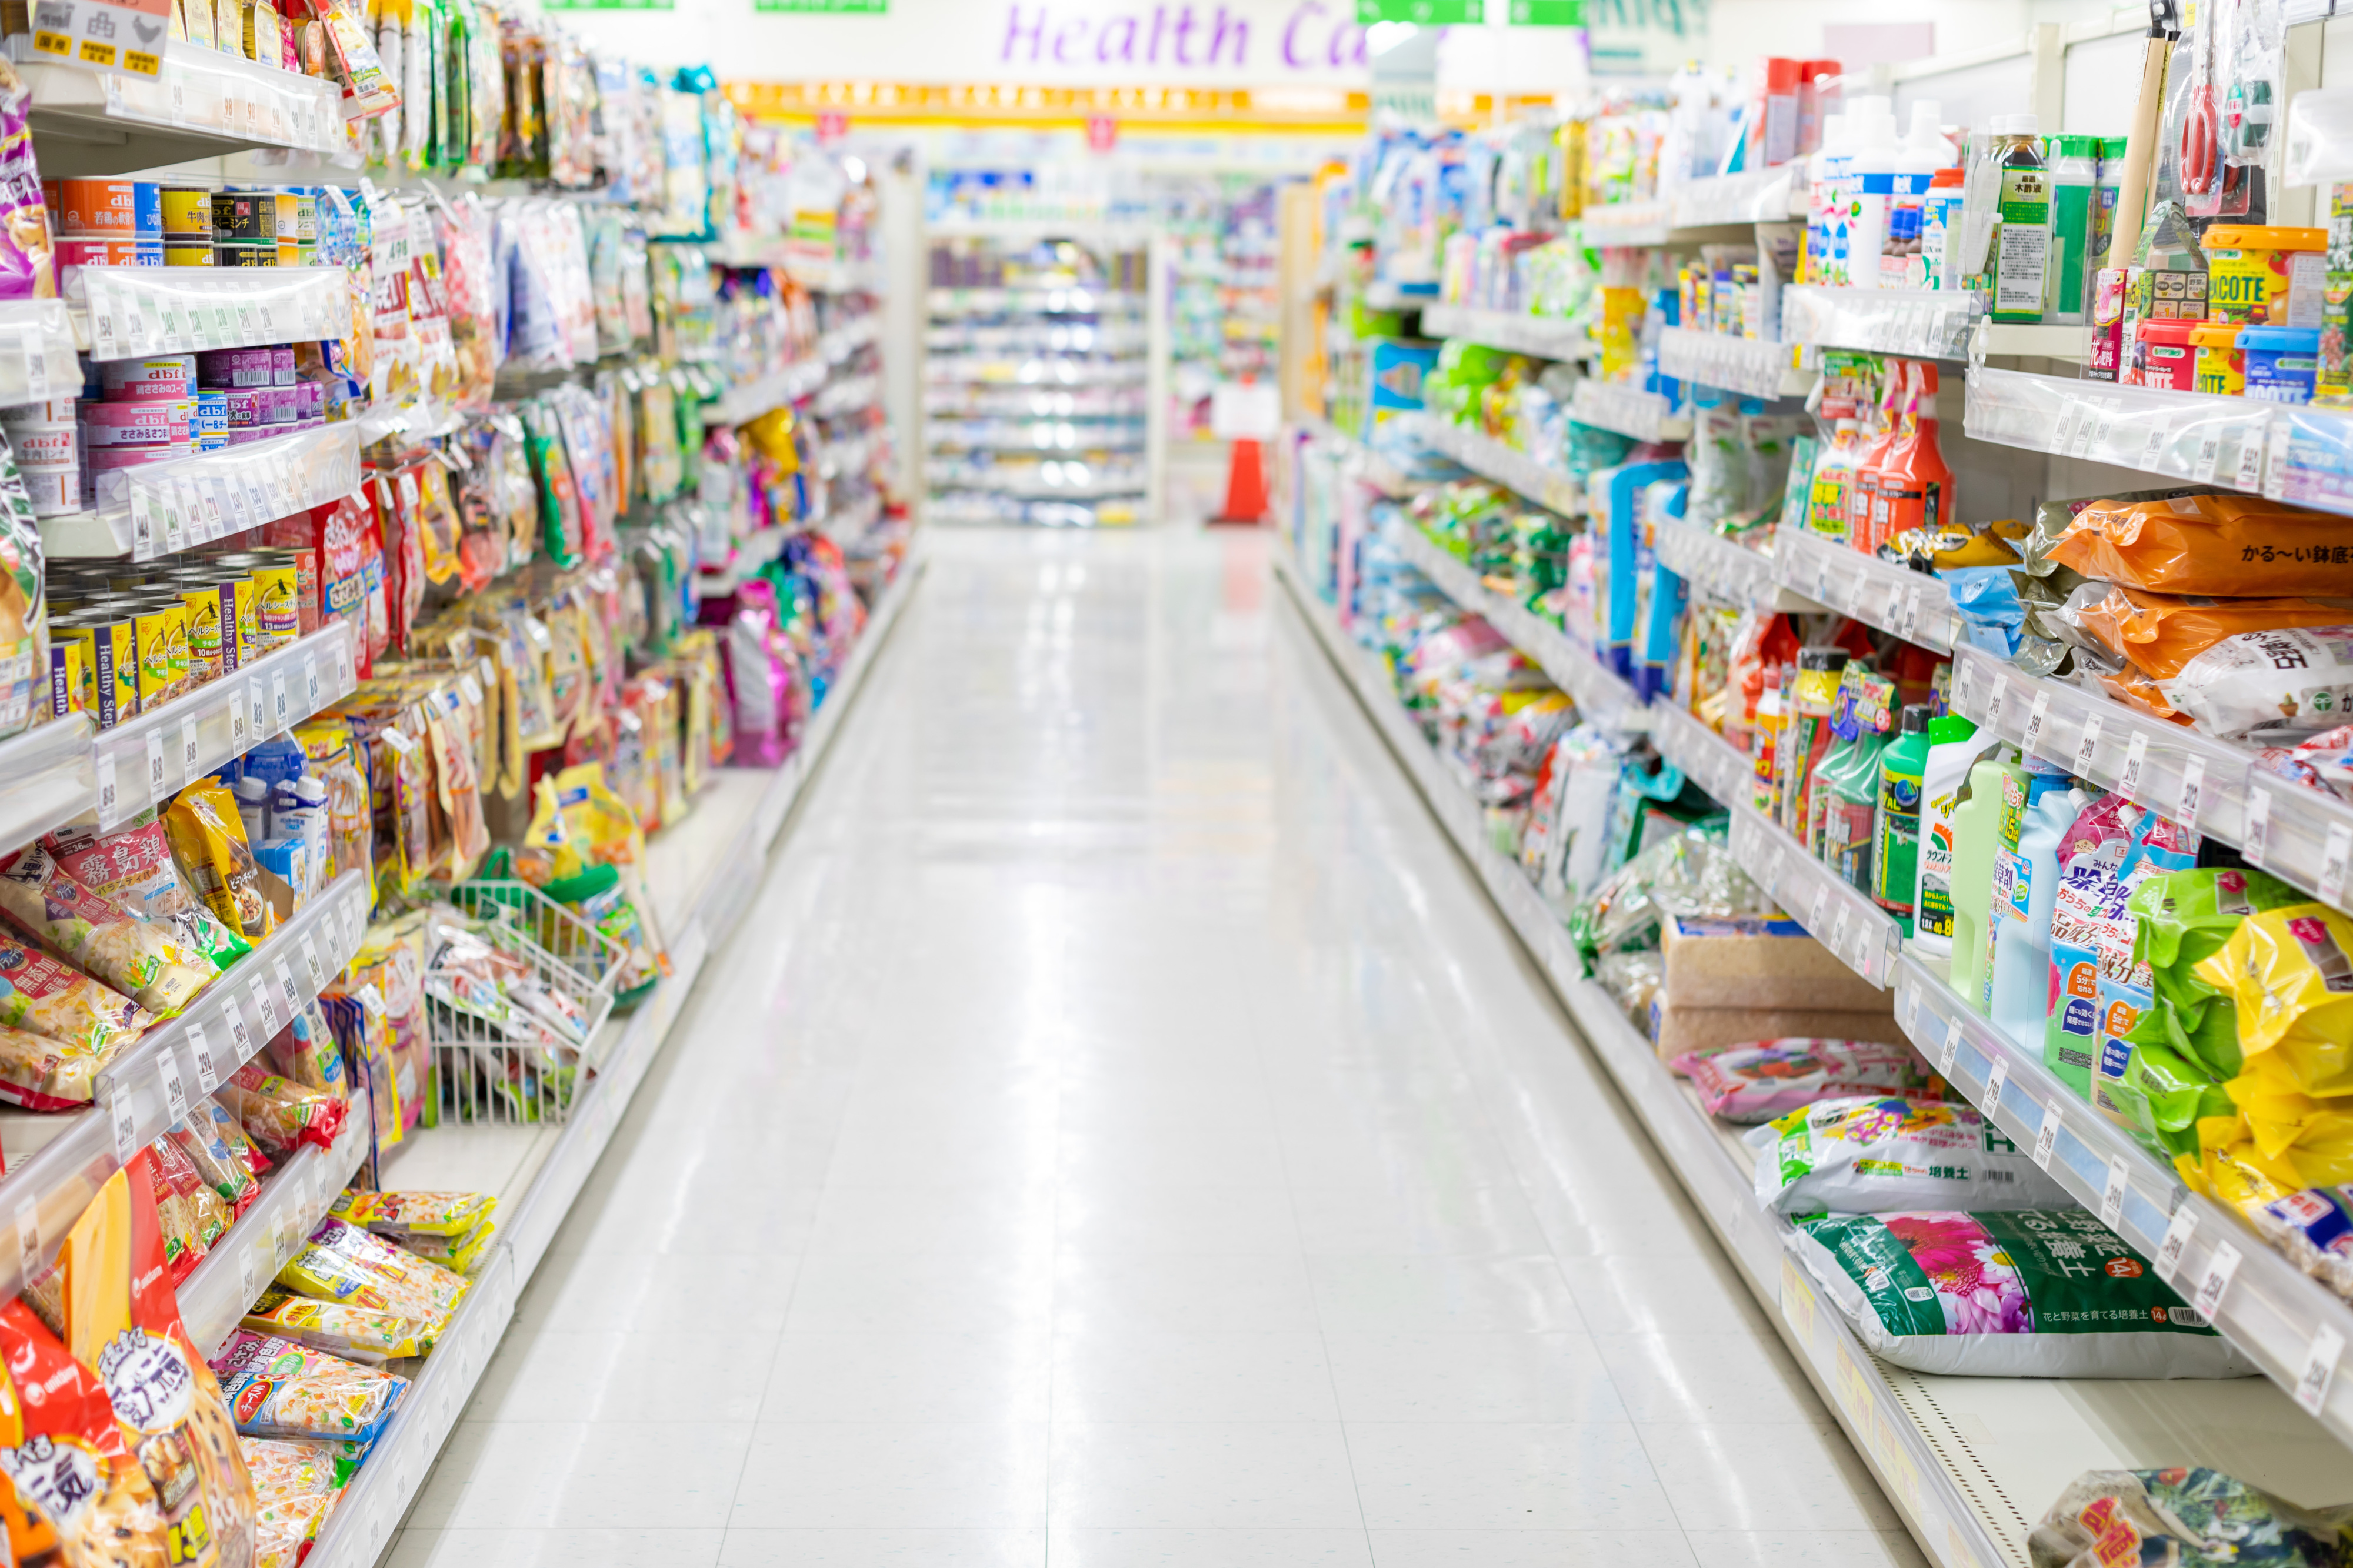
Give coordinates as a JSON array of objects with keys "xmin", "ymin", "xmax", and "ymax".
[{"xmin": 1791, "ymin": 1208, "xmax": 2259, "ymax": 1377}]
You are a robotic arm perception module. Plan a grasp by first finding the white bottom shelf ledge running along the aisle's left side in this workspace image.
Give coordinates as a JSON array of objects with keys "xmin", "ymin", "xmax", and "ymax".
[{"xmin": 294, "ymin": 553, "xmax": 922, "ymax": 1568}]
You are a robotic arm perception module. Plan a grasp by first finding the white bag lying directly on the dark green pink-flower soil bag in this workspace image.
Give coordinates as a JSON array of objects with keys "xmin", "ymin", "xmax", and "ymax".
[{"xmin": 1748, "ymin": 1097, "xmax": 2071, "ymax": 1215}]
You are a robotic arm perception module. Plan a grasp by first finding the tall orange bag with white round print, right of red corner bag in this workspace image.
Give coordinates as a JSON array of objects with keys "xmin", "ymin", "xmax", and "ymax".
[{"xmin": 59, "ymin": 1149, "xmax": 254, "ymax": 1568}]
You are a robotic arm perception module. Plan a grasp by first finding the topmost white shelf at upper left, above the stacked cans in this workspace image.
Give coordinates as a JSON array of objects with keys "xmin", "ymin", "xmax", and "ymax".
[{"xmin": 7, "ymin": 35, "xmax": 358, "ymax": 179}]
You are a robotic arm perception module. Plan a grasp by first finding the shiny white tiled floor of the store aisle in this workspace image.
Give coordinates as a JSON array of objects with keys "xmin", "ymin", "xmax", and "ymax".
[{"xmin": 395, "ymin": 530, "xmax": 1920, "ymax": 1568}]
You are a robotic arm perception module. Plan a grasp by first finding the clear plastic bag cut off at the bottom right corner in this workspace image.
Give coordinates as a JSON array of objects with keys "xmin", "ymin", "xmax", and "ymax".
[{"xmin": 2026, "ymin": 1467, "xmax": 2353, "ymax": 1568}]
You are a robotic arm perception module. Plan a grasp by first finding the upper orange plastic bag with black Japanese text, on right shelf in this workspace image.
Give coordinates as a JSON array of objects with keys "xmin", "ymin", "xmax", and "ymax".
[{"xmin": 2049, "ymin": 495, "xmax": 2353, "ymax": 598}]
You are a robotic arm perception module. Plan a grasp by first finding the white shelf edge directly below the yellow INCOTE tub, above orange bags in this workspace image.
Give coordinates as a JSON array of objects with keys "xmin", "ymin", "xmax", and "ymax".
[{"xmin": 1962, "ymin": 369, "xmax": 2278, "ymax": 492}]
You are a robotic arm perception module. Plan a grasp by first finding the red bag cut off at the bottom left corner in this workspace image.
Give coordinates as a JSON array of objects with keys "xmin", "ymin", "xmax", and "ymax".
[{"xmin": 0, "ymin": 1302, "xmax": 179, "ymax": 1568}]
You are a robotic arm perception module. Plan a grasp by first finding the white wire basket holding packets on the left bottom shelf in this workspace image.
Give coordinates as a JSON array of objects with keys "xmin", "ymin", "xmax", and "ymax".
[{"xmin": 426, "ymin": 880, "xmax": 624, "ymax": 1125}]
